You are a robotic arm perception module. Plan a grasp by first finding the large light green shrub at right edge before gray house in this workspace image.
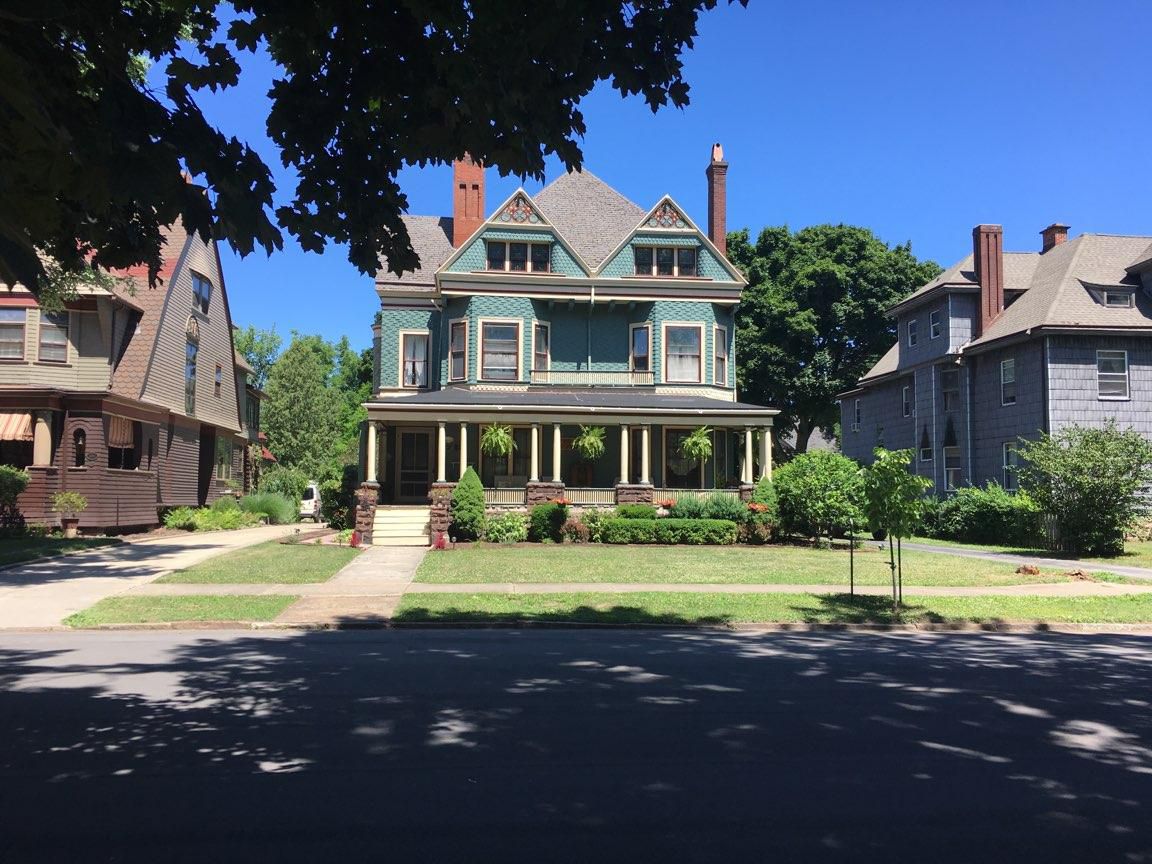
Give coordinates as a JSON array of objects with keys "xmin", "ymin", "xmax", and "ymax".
[{"xmin": 1020, "ymin": 420, "xmax": 1152, "ymax": 555}]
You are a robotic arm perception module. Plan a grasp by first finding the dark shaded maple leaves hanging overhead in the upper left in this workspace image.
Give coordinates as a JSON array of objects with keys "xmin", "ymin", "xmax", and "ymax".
[{"xmin": 0, "ymin": 0, "xmax": 746, "ymax": 291}]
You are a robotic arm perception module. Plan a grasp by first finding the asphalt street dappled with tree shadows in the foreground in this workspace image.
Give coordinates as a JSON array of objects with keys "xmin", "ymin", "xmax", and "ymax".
[{"xmin": 0, "ymin": 630, "xmax": 1152, "ymax": 864}]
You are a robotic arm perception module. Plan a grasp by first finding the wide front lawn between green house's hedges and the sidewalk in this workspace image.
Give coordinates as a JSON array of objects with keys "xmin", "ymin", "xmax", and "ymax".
[{"xmin": 416, "ymin": 543, "xmax": 1101, "ymax": 588}]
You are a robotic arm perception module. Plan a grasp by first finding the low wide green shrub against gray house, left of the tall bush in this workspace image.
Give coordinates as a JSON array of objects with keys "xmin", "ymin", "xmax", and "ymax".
[{"xmin": 935, "ymin": 482, "xmax": 1043, "ymax": 546}]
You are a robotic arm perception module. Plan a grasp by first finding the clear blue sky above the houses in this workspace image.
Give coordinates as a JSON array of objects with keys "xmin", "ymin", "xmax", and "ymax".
[{"xmin": 168, "ymin": 0, "xmax": 1152, "ymax": 347}]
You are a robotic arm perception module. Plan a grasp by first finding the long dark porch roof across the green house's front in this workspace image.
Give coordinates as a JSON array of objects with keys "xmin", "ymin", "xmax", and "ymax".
[{"xmin": 364, "ymin": 387, "xmax": 780, "ymax": 425}]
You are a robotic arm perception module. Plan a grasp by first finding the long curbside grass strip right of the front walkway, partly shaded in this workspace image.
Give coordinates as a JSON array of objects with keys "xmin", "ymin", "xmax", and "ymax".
[{"xmin": 394, "ymin": 591, "xmax": 1152, "ymax": 624}]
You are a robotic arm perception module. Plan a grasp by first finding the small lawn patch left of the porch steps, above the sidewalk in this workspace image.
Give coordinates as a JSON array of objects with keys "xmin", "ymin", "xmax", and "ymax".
[{"xmin": 157, "ymin": 540, "xmax": 359, "ymax": 585}]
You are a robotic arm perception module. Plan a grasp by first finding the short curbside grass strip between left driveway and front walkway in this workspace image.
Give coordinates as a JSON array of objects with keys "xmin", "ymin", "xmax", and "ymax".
[{"xmin": 65, "ymin": 594, "xmax": 297, "ymax": 627}]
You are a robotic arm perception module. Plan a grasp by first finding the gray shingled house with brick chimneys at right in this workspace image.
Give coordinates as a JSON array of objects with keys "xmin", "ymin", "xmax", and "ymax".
[{"xmin": 840, "ymin": 225, "xmax": 1152, "ymax": 493}]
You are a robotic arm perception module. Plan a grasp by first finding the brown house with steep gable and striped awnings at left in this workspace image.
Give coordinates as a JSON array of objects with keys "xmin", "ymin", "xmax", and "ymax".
[{"xmin": 0, "ymin": 226, "xmax": 259, "ymax": 529}]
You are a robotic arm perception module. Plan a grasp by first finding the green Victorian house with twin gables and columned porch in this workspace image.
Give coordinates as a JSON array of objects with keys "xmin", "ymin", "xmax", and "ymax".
[{"xmin": 361, "ymin": 144, "xmax": 776, "ymax": 543}]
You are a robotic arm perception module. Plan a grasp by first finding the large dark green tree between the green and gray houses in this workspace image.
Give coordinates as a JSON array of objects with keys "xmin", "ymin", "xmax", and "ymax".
[{"xmin": 728, "ymin": 225, "xmax": 940, "ymax": 453}]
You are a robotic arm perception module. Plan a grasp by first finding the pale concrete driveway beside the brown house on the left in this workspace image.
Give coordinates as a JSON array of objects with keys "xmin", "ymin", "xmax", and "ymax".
[{"xmin": 0, "ymin": 525, "xmax": 296, "ymax": 630}]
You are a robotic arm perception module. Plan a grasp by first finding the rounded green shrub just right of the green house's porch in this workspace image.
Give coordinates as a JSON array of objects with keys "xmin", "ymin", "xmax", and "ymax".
[{"xmin": 773, "ymin": 450, "xmax": 865, "ymax": 538}]
